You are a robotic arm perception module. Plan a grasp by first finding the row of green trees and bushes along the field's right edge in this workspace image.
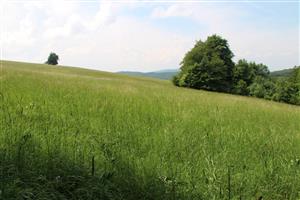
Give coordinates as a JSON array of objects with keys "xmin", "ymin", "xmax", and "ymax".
[{"xmin": 173, "ymin": 35, "xmax": 300, "ymax": 105}]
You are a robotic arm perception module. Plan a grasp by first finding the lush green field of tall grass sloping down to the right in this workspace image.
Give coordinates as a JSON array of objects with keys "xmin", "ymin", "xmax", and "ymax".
[{"xmin": 0, "ymin": 61, "xmax": 300, "ymax": 200}]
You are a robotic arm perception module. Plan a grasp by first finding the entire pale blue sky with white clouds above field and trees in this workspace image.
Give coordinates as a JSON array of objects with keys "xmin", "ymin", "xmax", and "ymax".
[{"xmin": 0, "ymin": 0, "xmax": 300, "ymax": 72}]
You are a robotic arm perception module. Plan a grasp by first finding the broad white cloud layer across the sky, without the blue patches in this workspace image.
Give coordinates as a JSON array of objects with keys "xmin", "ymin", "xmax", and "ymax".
[{"xmin": 0, "ymin": 1, "xmax": 299, "ymax": 71}]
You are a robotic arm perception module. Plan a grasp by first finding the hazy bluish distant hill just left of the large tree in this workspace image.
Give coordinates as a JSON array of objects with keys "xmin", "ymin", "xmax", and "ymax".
[{"xmin": 117, "ymin": 69, "xmax": 178, "ymax": 80}]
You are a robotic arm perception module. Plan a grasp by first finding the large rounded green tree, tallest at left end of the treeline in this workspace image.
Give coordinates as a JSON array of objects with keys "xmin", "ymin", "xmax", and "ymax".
[{"xmin": 173, "ymin": 35, "xmax": 234, "ymax": 92}]
